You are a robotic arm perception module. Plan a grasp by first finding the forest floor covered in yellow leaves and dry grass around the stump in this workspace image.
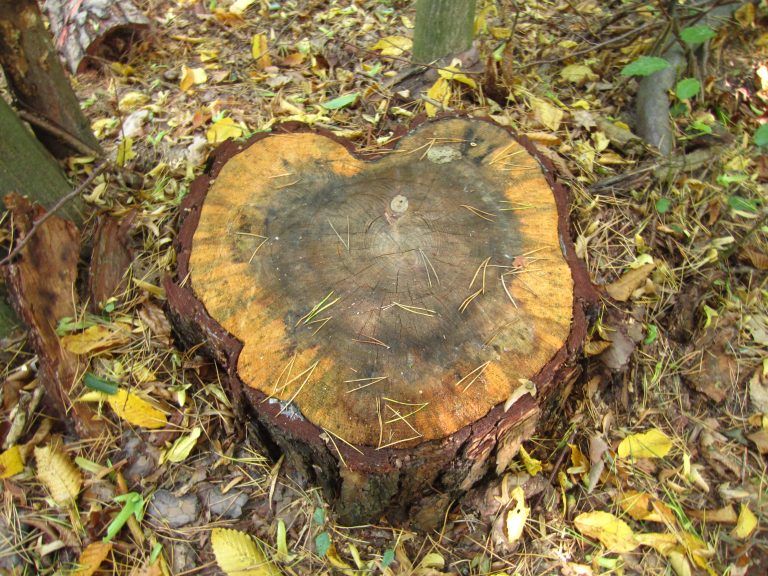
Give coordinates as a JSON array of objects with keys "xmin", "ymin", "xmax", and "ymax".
[{"xmin": 0, "ymin": 0, "xmax": 768, "ymax": 576}]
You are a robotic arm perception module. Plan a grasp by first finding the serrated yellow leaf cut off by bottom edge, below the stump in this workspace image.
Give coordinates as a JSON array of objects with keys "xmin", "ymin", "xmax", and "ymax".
[{"xmin": 211, "ymin": 528, "xmax": 281, "ymax": 576}]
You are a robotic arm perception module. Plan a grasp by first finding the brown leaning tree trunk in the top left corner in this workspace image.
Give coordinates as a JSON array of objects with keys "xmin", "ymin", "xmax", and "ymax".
[{"xmin": 0, "ymin": 0, "xmax": 100, "ymax": 158}]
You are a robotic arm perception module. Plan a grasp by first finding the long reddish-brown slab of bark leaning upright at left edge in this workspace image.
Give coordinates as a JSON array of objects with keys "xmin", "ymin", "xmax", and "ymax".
[{"xmin": 4, "ymin": 194, "xmax": 103, "ymax": 437}]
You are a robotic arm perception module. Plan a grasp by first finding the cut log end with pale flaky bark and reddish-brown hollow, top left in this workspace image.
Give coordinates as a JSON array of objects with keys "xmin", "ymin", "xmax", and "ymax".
[{"xmin": 45, "ymin": 0, "xmax": 149, "ymax": 74}]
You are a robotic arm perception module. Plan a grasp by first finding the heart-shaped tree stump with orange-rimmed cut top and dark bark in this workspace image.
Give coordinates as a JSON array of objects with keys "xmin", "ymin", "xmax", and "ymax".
[{"xmin": 166, "ymin": 117, "xmax": 592, "ymax": 526}]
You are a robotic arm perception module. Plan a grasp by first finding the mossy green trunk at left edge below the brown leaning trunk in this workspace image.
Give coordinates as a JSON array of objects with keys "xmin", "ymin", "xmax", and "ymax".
[{"xmin": 0, "ymin": 98, "xmax": 83, "ymax": 223}]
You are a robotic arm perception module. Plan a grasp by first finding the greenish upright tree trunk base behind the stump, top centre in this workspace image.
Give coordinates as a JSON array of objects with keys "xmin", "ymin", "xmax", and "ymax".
[{"xmin": 413, "ymin": 0, "xmax": 475, "ymax": 64}]
